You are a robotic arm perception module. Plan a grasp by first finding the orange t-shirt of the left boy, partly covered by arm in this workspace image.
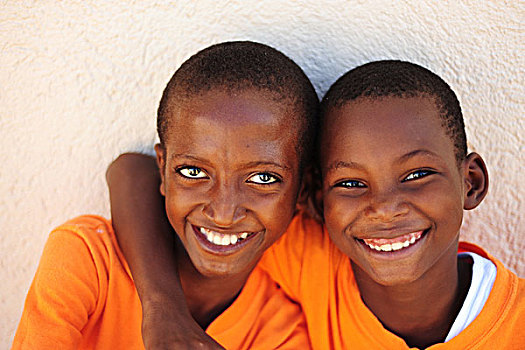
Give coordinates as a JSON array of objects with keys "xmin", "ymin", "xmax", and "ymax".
[{"xmin": 13, "ymin": 216, "xmax": 310, "ymax": 350}]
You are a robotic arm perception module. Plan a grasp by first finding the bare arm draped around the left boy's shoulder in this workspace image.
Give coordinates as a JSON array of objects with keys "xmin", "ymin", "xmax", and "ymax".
[{"xmin": 106, "ymin": 153, "xmax": 222, "ymax": 349}]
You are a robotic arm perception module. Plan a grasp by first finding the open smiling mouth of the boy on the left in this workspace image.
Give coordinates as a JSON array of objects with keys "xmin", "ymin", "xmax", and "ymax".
[{"xmin": 192, "ymin": 225, "xmax": 262, "ymax": 252}]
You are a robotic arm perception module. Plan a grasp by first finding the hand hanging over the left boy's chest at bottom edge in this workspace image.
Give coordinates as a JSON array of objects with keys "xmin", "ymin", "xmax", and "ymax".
[{"xmin": 142, "ymin": 302, "xmax": 224, "ymax": 350}]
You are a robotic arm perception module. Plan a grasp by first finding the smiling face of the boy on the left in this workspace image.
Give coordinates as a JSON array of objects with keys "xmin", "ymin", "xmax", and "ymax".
[{"xmin": 156, "ymin": 90, "xmax": 300, "ymax": 276}]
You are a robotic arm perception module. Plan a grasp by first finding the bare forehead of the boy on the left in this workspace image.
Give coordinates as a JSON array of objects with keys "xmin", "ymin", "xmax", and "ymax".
[{"xmin": 165, "ymin": 90, "xmax": 298, "ymax": 165}]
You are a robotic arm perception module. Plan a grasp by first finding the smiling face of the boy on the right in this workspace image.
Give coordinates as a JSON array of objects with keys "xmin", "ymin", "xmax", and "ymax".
[{"xmin": 322, "ymin": 97, "xmax": 469, "ymax": 285}]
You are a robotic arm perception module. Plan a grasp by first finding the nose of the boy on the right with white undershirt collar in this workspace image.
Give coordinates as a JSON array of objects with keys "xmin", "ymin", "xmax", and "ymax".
[{"xmin": 365, "ymin": 188, "xmax": 409, "ymax": 222}]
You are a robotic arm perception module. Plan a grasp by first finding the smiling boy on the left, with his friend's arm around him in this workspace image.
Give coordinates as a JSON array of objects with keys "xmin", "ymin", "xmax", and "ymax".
[{"xmin": 13, "ymin": 42, "xmax": 318, "ymax": 349}]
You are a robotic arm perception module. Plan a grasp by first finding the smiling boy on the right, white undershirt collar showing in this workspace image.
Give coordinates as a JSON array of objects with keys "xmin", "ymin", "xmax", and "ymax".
[{"xmin": 108, "ymin": 61, "xmax": 525, "ymax": 349}]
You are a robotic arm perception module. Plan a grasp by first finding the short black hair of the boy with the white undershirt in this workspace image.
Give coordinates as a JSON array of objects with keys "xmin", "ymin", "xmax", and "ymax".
[{"xmin": 321, "ymin": 60, "xmax": 467, "ymax": 165}]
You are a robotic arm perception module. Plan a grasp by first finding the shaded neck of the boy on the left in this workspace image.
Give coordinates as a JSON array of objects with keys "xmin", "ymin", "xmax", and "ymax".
[{"xmin": 177, "ymin": 241, "xmax": 249, "ymax": 329}]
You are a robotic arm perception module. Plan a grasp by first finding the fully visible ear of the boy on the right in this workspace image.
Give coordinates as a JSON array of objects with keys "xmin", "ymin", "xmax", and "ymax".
[{"xmin": 463, "ymin": 152, "xmax": 489, "ymax": 210}]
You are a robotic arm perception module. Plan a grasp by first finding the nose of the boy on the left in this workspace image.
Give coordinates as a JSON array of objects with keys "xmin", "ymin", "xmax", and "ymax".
[{"xmin": 202, "ymin": 183, "xmax": 246, "ymax": 227}]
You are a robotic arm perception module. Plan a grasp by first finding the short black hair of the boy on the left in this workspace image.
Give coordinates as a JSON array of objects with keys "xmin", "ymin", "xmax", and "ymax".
[{"xmin": 157, "ymin": 41, "xmax": 319, "ymax": 165}]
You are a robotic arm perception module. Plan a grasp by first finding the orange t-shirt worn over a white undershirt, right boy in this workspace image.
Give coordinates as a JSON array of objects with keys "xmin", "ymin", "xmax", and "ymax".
[{"xmin": 259, "ymin": 214, "xmax": 525, "ymax": 350}]
